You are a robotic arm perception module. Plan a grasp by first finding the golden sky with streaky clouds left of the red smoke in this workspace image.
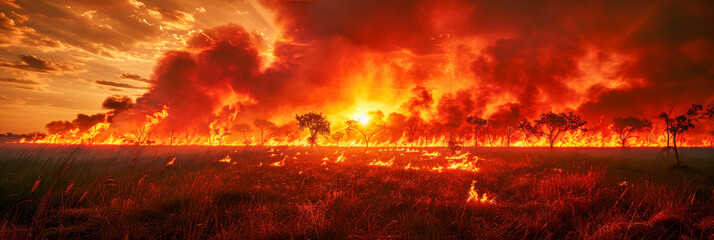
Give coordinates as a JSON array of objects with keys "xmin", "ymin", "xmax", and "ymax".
[{"xmin": 0, "ymin": 0, "xmax": 277, "ymax": 133}]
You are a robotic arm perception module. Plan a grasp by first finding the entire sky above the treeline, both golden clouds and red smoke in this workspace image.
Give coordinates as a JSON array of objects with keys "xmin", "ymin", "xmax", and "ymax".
[{"xmin": 0, "ymin": 0, "xmax": 714, "ymax": 136}]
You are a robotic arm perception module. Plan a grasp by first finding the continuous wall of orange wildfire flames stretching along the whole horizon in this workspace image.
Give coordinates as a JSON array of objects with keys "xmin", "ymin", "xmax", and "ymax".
[{"xmin": 15, "ymin": 101, "xmax": 714, "ymax": 148}]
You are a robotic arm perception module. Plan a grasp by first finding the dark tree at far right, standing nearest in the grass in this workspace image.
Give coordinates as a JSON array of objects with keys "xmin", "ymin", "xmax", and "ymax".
[{"xmin": 655, "ymin": 104, "xmax": 714, "ymax": 167}]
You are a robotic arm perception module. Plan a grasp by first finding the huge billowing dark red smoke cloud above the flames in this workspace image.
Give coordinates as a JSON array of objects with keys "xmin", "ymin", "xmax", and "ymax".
[{"xmin": 47, "ymin": 0, "xmax": 714, "ymax": 142}]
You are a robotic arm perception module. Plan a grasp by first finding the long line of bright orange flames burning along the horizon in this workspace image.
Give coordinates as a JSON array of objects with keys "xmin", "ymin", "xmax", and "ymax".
[{"xmin": 19, "ymin": 101, "xmax": 707, "ymax": 148}]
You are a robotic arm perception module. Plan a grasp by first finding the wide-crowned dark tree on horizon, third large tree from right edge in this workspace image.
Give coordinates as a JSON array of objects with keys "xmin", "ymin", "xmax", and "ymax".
[{"xmin": 535, "ymin": 112, "xmax": 587, "ymax": 149}]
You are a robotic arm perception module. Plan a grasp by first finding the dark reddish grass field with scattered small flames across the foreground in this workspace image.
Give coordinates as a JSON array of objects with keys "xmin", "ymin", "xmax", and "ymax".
[{"xmin": 0, "ymin": 144, "xmax": 714, "ymax": 239}]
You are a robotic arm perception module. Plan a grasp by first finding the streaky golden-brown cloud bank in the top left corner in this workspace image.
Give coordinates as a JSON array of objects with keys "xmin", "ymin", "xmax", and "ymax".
[{"xmin": 0, "ymin": 0, "xmax": 186, "ymax": 58}]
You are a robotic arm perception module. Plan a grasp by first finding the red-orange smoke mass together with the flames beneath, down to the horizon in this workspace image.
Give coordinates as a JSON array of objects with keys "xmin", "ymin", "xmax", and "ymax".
[{"xmin": 27, "ymin": 0, "xmax": 714, "ymax": 147}]
